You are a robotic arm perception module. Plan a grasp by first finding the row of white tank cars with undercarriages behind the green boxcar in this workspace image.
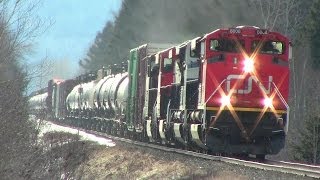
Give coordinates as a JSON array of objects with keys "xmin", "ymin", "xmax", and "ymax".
[{"xmin": 66, "ymin": 65, "xmax": 128, "ymax": 131}]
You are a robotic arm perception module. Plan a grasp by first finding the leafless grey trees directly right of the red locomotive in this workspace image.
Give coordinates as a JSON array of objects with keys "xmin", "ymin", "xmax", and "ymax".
[{"xmin": 251, "ymin": 0, "xmax": 316, "ymax": 162}]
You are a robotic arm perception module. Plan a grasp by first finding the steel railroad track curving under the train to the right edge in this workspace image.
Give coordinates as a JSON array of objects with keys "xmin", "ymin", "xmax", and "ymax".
[{"xmin": 50, "ymin": 121, "xmax": 320, "ymax": 178}]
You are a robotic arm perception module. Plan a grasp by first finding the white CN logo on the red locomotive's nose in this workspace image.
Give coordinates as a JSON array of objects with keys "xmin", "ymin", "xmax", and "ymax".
[{"xmin": 227, "ymin": 74, "xmax": 273, "ymax": 94}]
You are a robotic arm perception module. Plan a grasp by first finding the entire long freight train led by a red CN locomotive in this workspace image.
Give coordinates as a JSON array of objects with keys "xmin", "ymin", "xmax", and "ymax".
[{"xmin": 30, "ymin": 26, "xmax": 292, "ymax": 158}]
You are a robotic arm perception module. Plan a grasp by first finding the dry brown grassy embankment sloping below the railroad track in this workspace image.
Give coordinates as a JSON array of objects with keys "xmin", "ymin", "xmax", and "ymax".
[{"xmin": 28, "ymin": 133, "xmax": 301, "ymax": 180}]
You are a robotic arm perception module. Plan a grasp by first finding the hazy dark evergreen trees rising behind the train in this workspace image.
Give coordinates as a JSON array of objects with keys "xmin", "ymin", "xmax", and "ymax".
[{"xmin": 79, "ymin": 0, "xmax": 260, "ymax": 71}]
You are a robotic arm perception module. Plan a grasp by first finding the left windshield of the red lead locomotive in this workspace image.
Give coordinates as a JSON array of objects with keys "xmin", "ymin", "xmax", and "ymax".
[{"xmin": 210, "ymin": 39, "xmax": 244, "ymax": 53}]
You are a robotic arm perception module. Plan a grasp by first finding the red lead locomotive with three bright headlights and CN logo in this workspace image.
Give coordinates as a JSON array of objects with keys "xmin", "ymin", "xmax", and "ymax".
[{"xmin": 198, "ymin": 26, "xmax": 291, "ymax": 156}]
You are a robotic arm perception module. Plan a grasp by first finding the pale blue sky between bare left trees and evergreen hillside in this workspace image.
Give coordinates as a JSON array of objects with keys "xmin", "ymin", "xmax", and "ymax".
[{"xmin": 30, "ymin": 0, "xmax": 121, "ymax": 69}]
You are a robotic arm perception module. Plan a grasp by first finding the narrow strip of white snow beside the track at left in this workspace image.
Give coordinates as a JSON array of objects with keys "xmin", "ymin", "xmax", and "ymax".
[{"xmin": 38, "ymin": 120, "xmax": 116, "ymax": 147}]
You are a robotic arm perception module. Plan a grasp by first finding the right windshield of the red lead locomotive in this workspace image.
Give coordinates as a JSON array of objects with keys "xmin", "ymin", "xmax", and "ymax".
[{"xmin": 251, "ymin": 40, "xmax": 284, "ymax": 54}]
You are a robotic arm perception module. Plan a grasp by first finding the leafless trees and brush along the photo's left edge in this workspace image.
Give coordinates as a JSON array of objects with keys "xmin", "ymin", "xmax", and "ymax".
[{"xmin": 0, "ymin": 0, "xmax": 48, "ymax": 179}]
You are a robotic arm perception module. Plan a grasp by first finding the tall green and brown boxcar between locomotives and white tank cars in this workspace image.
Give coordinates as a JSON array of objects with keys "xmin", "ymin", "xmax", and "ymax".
[{"xmin": 126, "ymin": 43, "xmax": 173, "ymax": 135}]
